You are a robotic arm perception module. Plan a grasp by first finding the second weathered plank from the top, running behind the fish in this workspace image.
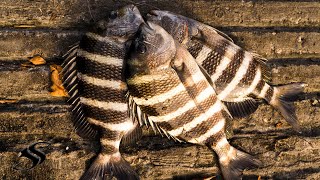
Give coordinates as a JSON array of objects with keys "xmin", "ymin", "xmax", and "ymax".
[{"xmin": 0, "ymin": 30, "xmax": 320, "ymax": 60}]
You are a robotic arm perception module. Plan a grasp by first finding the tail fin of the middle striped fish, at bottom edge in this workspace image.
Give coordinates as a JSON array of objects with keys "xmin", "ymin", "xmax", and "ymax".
[{"xmin": 219, "ymin": 149, "xmax": 262, "ymax": 180}]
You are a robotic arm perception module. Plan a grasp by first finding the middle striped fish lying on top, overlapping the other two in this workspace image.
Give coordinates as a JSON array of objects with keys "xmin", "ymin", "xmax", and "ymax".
[{"xmin": 127, "ymin": 22, "xmax": 260, "ymax": 179}]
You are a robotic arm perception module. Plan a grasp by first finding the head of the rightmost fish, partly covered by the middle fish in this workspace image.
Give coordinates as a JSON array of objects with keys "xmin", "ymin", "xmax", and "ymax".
[{"xmin": 147, "ymin": 10, "xmax": 192, "ymax": 44}]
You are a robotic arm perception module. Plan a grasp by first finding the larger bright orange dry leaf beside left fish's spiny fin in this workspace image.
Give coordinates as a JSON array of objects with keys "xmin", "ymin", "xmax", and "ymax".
[{"xmin": 50, "ymin": 64, "xmax": 68, "ymax": 97}]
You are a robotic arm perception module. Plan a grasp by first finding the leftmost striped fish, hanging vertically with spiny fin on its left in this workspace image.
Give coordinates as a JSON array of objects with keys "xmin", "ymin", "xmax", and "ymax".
[{"xmin": 62, "ymin": 5, "xmax": 144, "ymax": 180}]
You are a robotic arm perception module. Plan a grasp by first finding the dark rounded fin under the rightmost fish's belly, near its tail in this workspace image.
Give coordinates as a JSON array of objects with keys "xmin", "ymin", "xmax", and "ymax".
[{"xmin": 223, "ymin": 98, "xmax": 258, "ymax": 118}]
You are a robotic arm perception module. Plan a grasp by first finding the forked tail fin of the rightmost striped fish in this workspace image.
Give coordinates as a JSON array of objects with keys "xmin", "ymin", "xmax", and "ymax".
[{"xmin": 270, "ymin": 83, "xmax": 307, "ymax": 132}]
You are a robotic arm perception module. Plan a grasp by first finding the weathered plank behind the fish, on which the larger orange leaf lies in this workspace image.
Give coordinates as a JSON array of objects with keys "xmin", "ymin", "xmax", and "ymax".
[{"xmin": 0, "ymin": 60, "xmax": 320, "ymax": 102}]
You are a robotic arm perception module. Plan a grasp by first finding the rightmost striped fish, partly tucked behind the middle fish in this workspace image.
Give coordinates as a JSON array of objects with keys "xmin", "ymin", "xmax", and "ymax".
[{"xmin": 147, "ymin": 10, "xmax": 306, "ymax": 131}]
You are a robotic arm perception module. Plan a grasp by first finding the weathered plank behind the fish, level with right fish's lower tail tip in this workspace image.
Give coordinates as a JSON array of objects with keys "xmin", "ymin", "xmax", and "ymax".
[{"xmin": 0, "ymin": 100, "xmax": 320, "ymax": 145}]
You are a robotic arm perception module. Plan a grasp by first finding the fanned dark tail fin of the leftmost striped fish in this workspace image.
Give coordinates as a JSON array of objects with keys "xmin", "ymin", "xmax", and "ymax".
[{"xmin": 80, "ymin": 153, "xmax": 139, "ymax": 180}]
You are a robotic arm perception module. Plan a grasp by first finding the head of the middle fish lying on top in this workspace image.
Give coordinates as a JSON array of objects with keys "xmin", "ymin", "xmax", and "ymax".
[{"xmin": 127, "ymin": 22, "xmax": 176, "ymax": 76}]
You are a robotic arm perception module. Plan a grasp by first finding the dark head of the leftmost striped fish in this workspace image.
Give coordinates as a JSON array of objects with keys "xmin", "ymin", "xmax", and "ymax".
[{"xmin": 96, "ymin": 4, "xmax": 144, "ymax": 39}]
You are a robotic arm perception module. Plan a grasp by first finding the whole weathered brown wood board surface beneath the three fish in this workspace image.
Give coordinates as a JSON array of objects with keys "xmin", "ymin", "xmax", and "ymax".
[{"xmin": 0, "ymin": 0, "xmax": 320, "ymax": 179}]
